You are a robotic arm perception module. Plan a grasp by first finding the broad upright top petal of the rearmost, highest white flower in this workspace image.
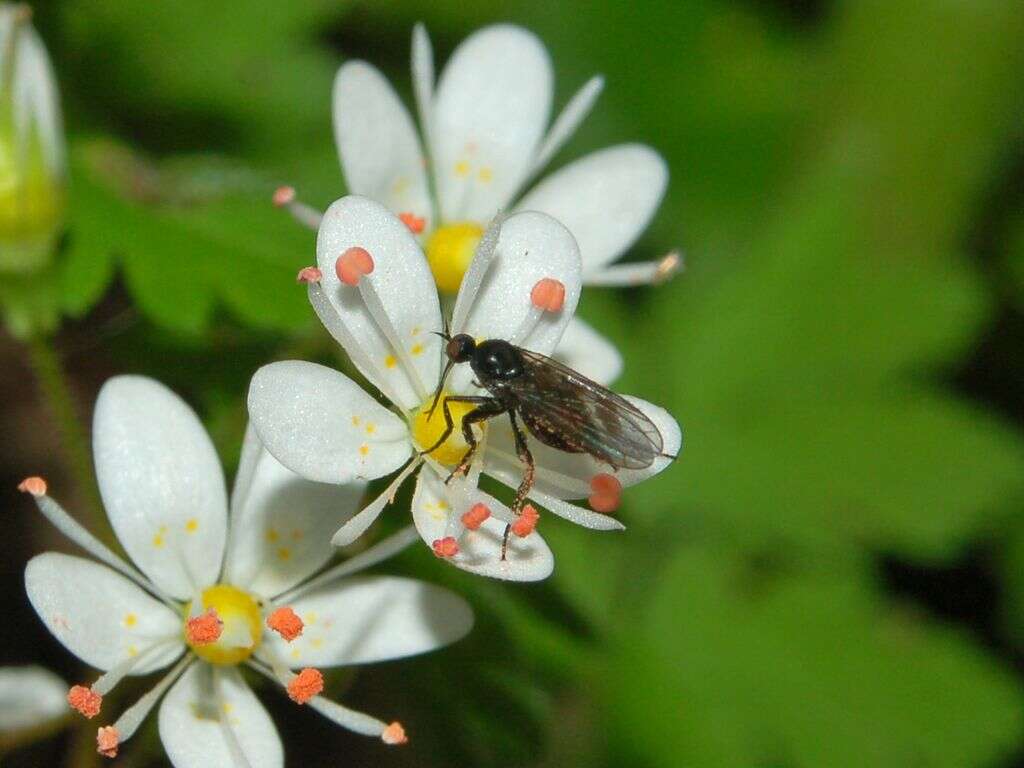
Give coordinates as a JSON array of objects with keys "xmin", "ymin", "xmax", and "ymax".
[{"xmin": 430, "ymin": 25, "xmax": 552, "ymax": 222}]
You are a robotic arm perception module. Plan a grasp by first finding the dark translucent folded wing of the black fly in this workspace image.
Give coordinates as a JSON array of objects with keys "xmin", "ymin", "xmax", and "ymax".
[{"xmin": 507, "ymin": 348, "xmax": 664, "ymax": 469}]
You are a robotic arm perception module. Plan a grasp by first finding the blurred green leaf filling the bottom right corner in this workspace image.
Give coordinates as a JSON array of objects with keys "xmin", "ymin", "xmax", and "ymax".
[{"xmin": 595, "ymin": 550, "xmax": 1024, "ymax": 768}]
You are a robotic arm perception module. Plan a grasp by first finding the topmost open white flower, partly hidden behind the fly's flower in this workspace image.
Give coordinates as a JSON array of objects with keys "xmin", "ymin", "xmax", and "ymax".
[{"xmin": 278, "ymin": 25, "xmax": 680, "ymax": 383}]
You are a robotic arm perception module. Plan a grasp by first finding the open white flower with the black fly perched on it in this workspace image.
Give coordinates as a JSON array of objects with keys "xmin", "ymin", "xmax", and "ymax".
[{"xmin": 249, "ymin": 196, "xmax": 681, "ymax": 581}]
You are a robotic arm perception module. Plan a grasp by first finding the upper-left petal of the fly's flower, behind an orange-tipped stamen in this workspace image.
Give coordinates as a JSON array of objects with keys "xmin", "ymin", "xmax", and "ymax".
[{"xmin": 316, "ymin": 196, "xmax": 441, "ymax": 410}]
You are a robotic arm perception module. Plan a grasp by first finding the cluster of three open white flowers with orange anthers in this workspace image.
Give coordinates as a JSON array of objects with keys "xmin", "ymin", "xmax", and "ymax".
[{"xmin": 20, "ymin": 20, "xmax": 682, "ymax": 768}]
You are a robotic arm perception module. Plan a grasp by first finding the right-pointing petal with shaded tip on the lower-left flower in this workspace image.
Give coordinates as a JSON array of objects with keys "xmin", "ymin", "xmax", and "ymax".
[{"xmin": 265, "ymin": 577, "xmax": 473, "ymax": 668}]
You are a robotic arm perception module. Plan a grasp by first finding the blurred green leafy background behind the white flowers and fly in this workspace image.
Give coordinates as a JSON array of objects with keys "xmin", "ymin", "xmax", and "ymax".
[{"xmin": 6, "ymin": 0, "xmax": 1024, "ymax": 768}]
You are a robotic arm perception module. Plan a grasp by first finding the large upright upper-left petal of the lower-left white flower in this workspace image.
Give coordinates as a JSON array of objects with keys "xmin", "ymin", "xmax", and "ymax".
[{"xmin": 92, "ymin": 376, "xmax": 227, "ymax": 599}]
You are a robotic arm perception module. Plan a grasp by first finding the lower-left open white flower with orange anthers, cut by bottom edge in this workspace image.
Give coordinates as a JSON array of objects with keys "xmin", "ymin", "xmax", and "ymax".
[{"xmin": 20, "ymin": 376, "xmax": 472, "ymax": 768}]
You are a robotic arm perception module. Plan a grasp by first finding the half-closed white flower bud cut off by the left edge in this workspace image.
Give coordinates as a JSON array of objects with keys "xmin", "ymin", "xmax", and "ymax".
[{"xmin": 0, "ymin": 3, "xmax": 65, "ymax": 271}]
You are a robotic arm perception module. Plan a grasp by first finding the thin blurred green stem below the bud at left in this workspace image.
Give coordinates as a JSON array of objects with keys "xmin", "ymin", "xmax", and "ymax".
[{"xmin": 29, "ymin": 336, "xmax": 116, "ymax": 546}]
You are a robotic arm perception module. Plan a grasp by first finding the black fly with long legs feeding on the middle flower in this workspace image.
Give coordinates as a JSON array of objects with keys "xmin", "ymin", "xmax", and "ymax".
[{"xmin": 421, "ymin": 334, "xmax": 675, "ymax": 560}]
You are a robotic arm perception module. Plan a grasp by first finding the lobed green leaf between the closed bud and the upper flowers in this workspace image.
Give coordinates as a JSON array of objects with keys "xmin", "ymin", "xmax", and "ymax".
[{"xmin": 62, "ymin": 139, "xmax": 313, "ymax": 334}]
